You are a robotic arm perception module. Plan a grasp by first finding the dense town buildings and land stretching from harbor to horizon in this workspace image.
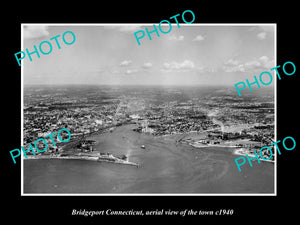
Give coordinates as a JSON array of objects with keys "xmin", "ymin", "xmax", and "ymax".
[{"xmin": 23, "ymin": 86, "xmax": 274, "ymax": 159}]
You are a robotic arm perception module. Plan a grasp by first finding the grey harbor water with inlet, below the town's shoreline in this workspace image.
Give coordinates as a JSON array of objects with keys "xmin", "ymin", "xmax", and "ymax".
[{"xmin": 24, "ymin": 125, "xmax": 274, "ymax": 194}]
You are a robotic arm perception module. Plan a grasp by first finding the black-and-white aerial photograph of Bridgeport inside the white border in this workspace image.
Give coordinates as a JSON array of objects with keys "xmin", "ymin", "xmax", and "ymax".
[{"xmin": 21, "ymin": 23, "xmax": 276, "ymax": 195}]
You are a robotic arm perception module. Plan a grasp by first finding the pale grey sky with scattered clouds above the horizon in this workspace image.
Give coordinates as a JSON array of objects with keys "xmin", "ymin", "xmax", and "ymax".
[{"xmin": 22, "ymin": 23, "xmax": 275, "ymax": 85}]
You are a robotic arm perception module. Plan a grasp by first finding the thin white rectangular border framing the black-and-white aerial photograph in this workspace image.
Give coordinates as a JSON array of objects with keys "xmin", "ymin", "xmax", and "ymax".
[{"xmin": 21, "ymin": 23, "xmax": 277, "ymax": 196}]
